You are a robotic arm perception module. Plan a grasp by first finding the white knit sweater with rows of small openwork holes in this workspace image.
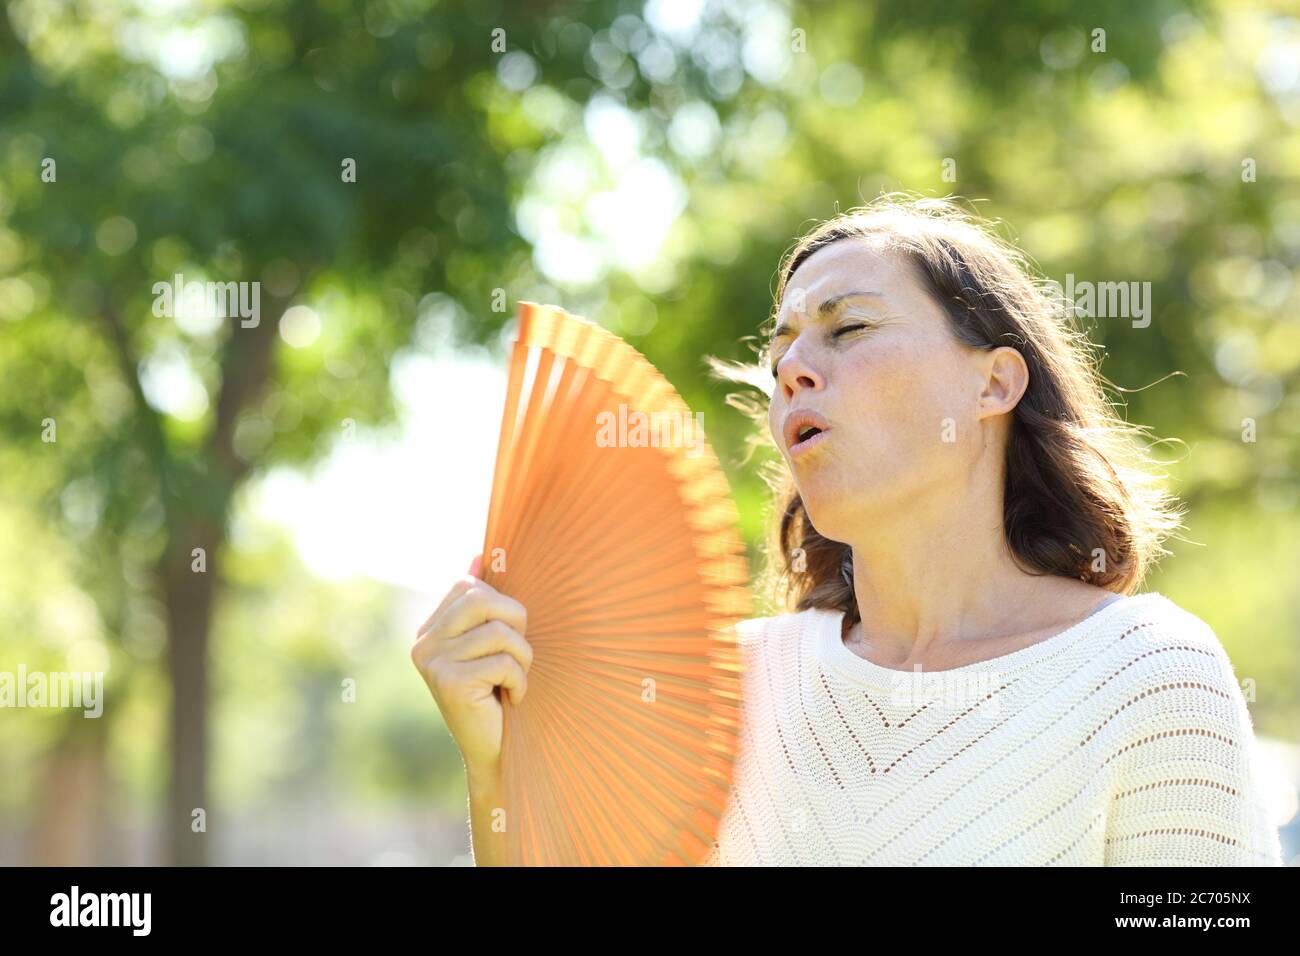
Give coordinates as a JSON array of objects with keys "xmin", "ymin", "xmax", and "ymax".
[{"xmin": 703, "ymin": 593, "xmax": 1282, "ymax": 866}]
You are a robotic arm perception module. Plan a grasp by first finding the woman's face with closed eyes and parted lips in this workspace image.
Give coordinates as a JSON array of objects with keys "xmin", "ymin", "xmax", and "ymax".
[{"xmin": 768, "ymin": 238, "xmax": 998, "ymax": 541}]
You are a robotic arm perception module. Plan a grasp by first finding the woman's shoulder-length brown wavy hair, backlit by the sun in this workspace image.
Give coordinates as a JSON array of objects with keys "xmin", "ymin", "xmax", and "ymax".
[{"xmin": 706, "ymin": 194, "xmax": 1182, "ymax": 626}]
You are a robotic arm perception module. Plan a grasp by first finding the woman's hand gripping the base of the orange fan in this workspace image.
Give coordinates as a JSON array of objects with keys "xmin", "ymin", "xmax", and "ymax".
[{"xmin": 411, "ymin": 555, "xmax": 533, "ymax": 792}]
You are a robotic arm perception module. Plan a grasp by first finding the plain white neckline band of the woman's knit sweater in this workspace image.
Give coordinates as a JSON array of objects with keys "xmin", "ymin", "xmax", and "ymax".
[{"xmin": 811, "ymin": 592, "xmax": 1165, "ymax": 688}]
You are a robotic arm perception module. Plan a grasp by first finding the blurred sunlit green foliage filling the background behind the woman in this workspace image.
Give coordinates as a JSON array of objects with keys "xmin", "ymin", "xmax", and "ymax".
[{"xmin": 0, "ymin": 0, "xmax": 1300, "ymax": 863}]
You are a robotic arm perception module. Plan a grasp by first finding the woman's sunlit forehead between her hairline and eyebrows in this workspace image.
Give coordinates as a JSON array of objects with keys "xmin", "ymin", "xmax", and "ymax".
[{"xmin": 780, "ymin": 237, "xmax": 920, "ymax": 316}]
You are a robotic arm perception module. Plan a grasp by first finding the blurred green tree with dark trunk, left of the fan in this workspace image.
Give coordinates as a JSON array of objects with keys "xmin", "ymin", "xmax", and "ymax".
[{"xmin": 0, "ymin": 1, "xmax": 579, "ymax": 864}]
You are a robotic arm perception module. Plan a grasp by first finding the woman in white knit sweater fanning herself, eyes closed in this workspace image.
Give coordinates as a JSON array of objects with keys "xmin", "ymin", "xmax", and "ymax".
[{"xmin": 412, "ymin": 198, "xmax": 1281, "ymax": 866}]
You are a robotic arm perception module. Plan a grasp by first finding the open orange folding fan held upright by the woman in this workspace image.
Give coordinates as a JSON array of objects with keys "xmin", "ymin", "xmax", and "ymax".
[{"xmin": 481, "ymin": 302, "xmax": 750, "ymax": 866}]
